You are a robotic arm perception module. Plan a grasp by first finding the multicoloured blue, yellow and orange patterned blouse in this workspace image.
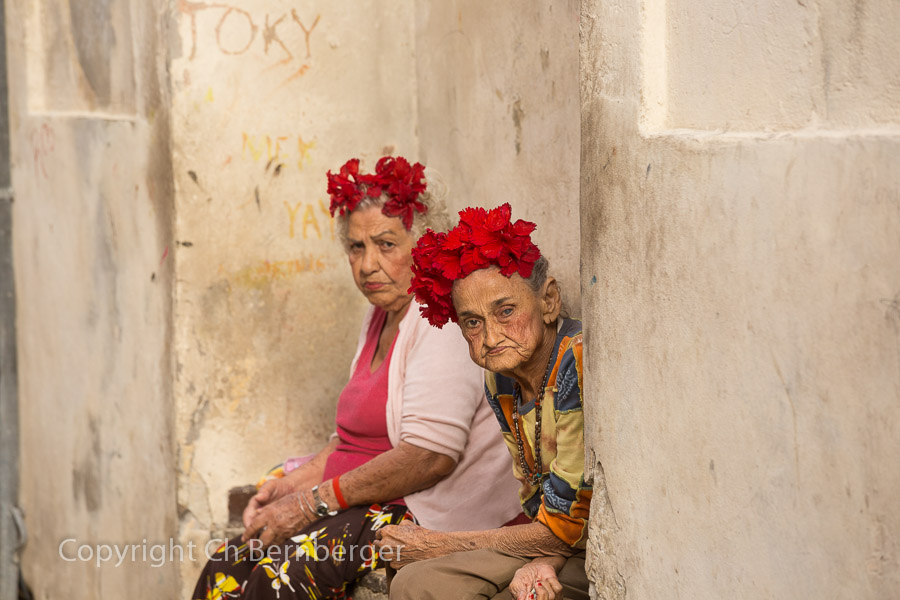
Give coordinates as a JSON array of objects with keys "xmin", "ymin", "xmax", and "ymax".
[{"xmin": 485, "ymin": 319, "xmax": 591, "ymax": 548}]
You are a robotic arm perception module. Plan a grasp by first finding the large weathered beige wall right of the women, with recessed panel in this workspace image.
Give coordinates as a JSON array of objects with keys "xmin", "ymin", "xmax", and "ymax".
[{"xmin": 581, "ymin": 0, "xmax": 900, "ymax": 599}]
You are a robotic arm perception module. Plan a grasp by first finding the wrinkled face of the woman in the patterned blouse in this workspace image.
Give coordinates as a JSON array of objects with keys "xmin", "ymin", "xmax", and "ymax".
[{"xmin": 453, "ymin": 267, "xmax": 545, "ymax": 373}]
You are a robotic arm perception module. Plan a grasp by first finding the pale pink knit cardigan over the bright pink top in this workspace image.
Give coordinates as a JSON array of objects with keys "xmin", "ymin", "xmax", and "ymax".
[{"xmin": 350, "ymin": 302, "xmax": 522, "ymax": 531}]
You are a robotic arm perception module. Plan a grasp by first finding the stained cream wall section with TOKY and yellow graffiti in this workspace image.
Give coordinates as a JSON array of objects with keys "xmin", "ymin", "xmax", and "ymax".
[{"xmin": 171, "ymin": 0, "xmax": 418, "ymax": 587}]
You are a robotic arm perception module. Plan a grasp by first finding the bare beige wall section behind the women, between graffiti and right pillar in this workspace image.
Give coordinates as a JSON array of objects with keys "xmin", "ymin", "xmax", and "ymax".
[{"xmin": 415, "ymin": 0, "xmax": 581, "ymax": 315}]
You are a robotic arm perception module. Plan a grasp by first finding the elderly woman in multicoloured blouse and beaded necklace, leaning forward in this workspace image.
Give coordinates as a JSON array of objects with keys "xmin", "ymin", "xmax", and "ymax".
[{"xmin": 376, "ymin": 204, "xmax": 591, "ymax": 600}]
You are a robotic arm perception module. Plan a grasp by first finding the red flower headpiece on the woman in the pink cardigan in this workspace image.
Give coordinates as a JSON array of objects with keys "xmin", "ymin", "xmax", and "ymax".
[{"xmin": 328, "ymin": 156, "xmax": 428, "ymax": 231}]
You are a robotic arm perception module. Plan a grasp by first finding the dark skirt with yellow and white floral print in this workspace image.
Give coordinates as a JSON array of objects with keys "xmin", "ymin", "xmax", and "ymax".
[{"xmin": 192, "ymin": 504, "xmax": 414, "ymax": 600}]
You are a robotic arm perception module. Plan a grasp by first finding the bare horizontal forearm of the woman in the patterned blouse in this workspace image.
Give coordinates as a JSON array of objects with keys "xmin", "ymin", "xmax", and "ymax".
[{"xmin": 432, "ymin": 521, "xmax": 575, "ymax": 558}]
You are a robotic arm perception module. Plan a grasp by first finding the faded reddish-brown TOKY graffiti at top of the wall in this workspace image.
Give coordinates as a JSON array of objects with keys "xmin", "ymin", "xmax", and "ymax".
[{"xmin": 178, "ymin": 0, "xmax": 322, "ymax": 83}]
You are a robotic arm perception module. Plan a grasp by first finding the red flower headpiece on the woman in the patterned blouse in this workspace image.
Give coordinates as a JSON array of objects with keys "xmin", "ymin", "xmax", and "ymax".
[{"xmin": 409, "ymin": 204, "xmax": 541, "ymax": 328}]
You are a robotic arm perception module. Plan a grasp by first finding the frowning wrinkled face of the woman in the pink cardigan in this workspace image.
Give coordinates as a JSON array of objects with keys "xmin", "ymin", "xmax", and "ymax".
[{"xmin": 347, "ymin": 206, "xmax": 414, "ymax": 311}]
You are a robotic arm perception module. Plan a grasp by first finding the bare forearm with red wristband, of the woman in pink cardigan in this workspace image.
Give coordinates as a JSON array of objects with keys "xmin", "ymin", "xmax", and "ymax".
[{"xmin": 320, "ymin": 442, "xmax": 456, "ymax": 506}]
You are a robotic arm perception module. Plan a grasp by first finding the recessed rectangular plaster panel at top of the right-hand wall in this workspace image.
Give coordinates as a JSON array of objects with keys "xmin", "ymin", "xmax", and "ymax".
[{"xmin": 645, "ymin": 0, "xmax": 900, "ymax": 131}]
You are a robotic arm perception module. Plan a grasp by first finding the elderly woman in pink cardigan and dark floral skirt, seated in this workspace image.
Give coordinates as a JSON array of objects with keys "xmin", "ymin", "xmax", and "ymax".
[{"xmin": 193, "ymin": 157, "xmax": 521, "ymax": 600}]
